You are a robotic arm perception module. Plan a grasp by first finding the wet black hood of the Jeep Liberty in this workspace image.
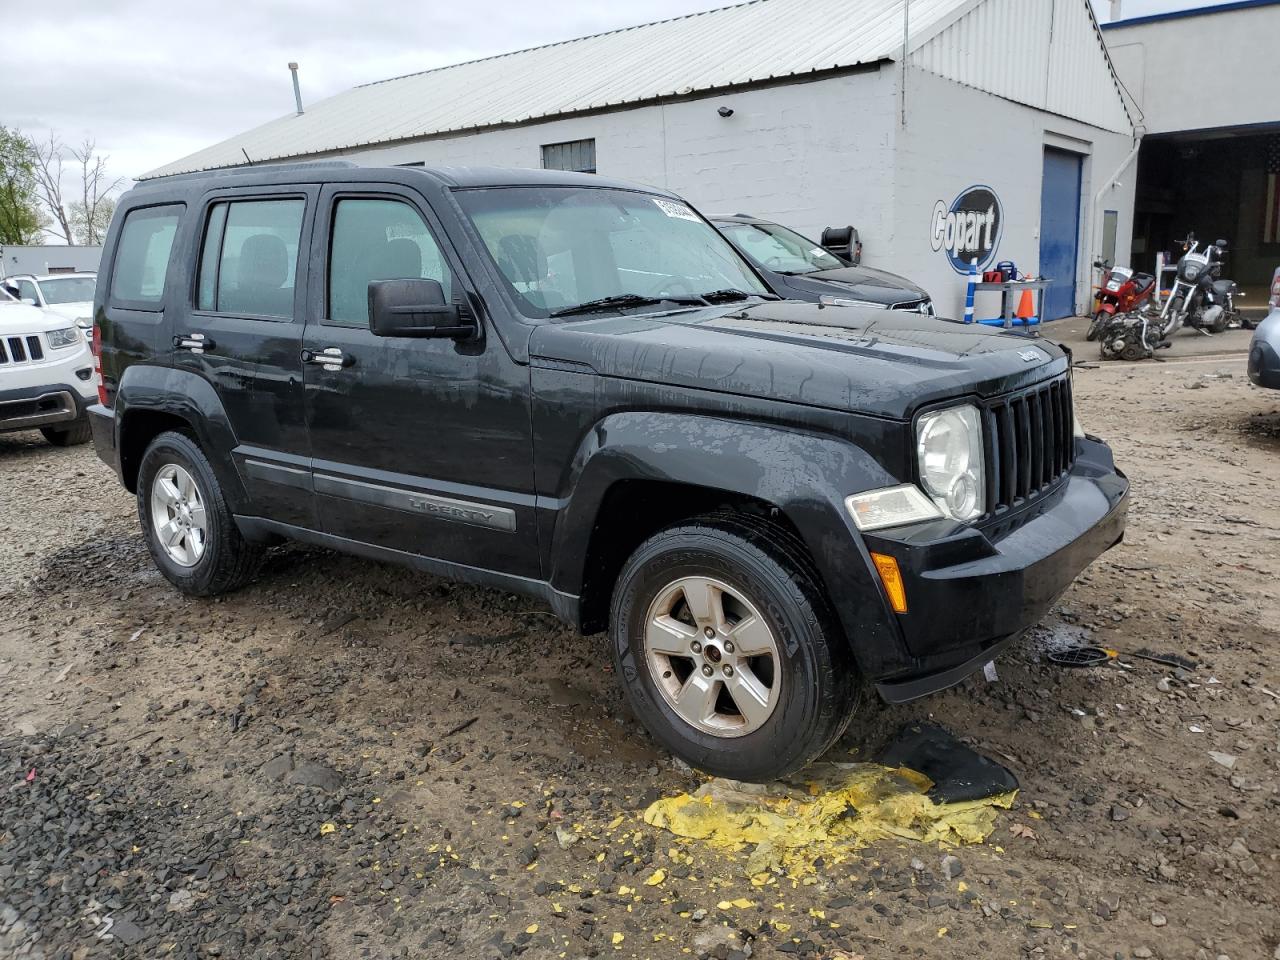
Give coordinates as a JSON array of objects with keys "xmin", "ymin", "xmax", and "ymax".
[{"xmin": 530, "ymin": 301, "xmax": 1068, "ymax": 419}]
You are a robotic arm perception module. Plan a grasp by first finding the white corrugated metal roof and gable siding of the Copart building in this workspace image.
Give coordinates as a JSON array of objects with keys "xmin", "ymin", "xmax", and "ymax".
[{"xmin": 142, "ymin": 0, "xmax": 1126, "ymax": 179}]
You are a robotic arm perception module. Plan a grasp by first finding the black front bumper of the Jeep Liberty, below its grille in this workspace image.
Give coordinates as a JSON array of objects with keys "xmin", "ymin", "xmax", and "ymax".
[{"xmin": 865, "ymin": 439, "xmax": 1129, "ymax": 703}]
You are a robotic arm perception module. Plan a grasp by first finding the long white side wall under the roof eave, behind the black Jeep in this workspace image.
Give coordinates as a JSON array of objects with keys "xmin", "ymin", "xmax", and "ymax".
[{"xmin": 344, "ymin": 67, "xmax": 897, "ymax": 269}]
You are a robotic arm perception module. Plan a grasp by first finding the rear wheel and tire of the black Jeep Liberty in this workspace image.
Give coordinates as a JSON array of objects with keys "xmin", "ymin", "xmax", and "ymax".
[{"xmin": 137, "ymin": 431, "xmax": 262, "ymax": 596}]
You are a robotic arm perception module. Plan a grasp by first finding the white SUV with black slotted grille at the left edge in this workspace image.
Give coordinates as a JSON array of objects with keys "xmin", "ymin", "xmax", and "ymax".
[{"xmin": 0, "ymin": 287, "xmax": 97, "ymax": 447}]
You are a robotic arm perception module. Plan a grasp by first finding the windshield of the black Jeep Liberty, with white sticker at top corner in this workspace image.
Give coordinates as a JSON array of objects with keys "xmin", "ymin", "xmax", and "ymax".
[{"xmin": 456, "ymin": 187, "xmax": 771, "ymax": 317}]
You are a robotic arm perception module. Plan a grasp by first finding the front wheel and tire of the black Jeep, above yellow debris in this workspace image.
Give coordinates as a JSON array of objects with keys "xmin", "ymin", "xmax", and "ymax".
[{"xmin": 609, "ymin": 515, "xmax": 859, "ymax": 782}]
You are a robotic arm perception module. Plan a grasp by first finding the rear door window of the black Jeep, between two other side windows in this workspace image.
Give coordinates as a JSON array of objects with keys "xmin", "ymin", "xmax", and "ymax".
[{"xmin": 196, "ymin": 198, "xmax": 306, "ymax": 319}]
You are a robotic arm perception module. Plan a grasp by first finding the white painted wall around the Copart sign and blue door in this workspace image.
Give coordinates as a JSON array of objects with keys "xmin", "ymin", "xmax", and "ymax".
[{"xmin": 892, "ymin": 68, "xmax": 1134, "ymax": 323}]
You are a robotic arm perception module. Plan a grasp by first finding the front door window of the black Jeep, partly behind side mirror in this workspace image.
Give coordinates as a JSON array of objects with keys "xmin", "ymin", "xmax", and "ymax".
[{"xmin": 329, "ymin": 200, "xmax": 452, "ymax": 326}]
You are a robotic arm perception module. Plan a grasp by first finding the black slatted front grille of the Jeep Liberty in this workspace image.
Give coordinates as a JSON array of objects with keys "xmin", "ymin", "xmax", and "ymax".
[{"xmin": 983, "ymin": 375, "xmax": 1075, "ymax": 515}]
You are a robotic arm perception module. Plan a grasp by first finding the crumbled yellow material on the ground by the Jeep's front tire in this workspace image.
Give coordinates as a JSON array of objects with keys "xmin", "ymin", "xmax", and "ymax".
[{"xmin": 644, "ymin": 763, "xmax": 1016, "ymax": 877}]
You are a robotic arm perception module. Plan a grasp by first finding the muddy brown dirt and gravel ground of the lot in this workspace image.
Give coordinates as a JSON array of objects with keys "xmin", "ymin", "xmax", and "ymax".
[{"xmin": 0, "ymin": 338, "xmax": 1280, "ymax": 960}]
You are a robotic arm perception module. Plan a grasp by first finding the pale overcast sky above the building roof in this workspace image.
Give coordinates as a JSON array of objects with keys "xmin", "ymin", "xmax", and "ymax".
[{"xmin": 0, "ymin": 0, "xmax": 1239, "ymax": 189}]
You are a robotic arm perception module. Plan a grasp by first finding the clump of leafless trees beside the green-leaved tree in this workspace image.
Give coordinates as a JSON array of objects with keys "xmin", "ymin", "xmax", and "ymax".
[{"xmin": 36, "ymin": 132, "xmax": 124, "ymax": 246}]
